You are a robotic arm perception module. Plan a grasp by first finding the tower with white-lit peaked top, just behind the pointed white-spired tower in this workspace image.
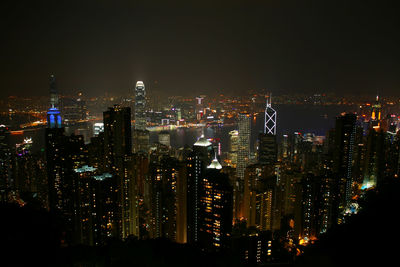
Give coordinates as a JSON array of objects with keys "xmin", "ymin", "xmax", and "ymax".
[{"xmin": 186, "ymin": 136, "xmax": 213, "ymax": 243}]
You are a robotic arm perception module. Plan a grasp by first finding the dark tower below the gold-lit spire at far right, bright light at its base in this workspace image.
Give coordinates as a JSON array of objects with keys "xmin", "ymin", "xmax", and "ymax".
[{"xmin": 361, "ymin": 128, "xmax": 385, "ymax": 189}]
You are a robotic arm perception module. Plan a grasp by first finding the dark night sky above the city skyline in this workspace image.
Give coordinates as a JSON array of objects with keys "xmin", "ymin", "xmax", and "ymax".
[{"xmin": 0, "ymin": 0, "xmax": 400, "ymax": 96}]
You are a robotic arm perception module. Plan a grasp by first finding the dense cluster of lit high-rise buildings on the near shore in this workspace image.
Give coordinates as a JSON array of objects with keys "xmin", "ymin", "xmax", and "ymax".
[{"xmin": 0, "ymin": 76, "xmax": 400, "ymax": 264}]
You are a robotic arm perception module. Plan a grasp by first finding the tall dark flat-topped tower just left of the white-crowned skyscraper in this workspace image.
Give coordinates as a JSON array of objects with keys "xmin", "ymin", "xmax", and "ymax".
[{"xmin": 103, "ymin": 105, "xmax": 138, "ymax": 238}]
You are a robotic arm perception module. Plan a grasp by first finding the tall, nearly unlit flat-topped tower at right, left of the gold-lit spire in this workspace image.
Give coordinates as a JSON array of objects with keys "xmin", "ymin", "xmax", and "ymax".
[{"xmin": 333, "ymin": 114, "xmax": 357, "ymax": 223}]
